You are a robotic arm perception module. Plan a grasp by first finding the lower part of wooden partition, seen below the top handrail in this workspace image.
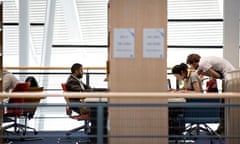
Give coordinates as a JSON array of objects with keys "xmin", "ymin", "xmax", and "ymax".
[{"xmin": 109, "ymin": 98, "xmax": 168, "ymax": 144}]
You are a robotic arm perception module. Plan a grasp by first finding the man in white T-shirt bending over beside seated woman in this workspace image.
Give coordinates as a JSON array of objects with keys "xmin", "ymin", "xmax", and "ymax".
[{"xmin": 186, "ymin": 54, "xmax": 235, "ymax": 79}]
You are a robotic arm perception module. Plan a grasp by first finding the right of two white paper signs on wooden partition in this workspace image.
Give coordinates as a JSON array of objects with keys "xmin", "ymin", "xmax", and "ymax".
[{"xmin": 143, "ymin": 28, "xmax": 164, "ymax": 58}]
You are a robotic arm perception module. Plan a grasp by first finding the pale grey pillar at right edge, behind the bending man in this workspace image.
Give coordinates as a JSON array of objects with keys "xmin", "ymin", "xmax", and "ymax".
[{"xmin": 223, "ymin": 0, "xmax": 240, "ymax": 68}]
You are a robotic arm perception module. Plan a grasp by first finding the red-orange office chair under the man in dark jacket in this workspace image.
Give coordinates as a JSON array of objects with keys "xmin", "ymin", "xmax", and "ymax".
[{"xmin": 58, "ymin": 83, "xmax": 90, "ymax": 143}]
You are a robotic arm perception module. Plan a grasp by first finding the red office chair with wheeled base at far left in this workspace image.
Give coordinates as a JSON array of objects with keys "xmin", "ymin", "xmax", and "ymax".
[{"xmin": 3, "ymin": 82, "xmax": 30, "ymax": 134}]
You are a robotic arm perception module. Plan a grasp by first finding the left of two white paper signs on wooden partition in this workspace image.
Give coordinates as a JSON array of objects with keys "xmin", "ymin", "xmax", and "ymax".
[{"xmin": 113, "ymin": 28, "xmax": 135, "ymax": 58}]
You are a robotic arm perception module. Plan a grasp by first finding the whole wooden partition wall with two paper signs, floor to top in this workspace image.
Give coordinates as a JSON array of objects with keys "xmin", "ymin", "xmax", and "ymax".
[{"xmin": 108, "ymin": 0, "xmax": 168, "ymax": 144}]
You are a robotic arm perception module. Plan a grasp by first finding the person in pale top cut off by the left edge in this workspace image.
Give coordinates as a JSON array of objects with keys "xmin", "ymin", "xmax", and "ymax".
[{"xmin": 3, "ymin": 69, "xmax": 19, "ymax": 92}]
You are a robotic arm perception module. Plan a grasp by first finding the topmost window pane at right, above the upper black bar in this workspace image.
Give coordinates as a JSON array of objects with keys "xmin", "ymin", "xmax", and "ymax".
[{"xmin": 168, "ymin": 0, "xmax": 223, "ymax": 19}]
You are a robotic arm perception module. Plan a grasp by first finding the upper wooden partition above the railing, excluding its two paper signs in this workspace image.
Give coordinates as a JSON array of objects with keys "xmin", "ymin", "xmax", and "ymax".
[{"xmin": 109, "ymin": 0, "xmax": 167, "ymax": 92}]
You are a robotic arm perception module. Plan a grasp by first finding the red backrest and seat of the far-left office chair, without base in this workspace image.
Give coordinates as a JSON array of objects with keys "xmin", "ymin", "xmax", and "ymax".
[{"xmin": 7, "ymin": 82, "xmax": 30, "ymax": 115}]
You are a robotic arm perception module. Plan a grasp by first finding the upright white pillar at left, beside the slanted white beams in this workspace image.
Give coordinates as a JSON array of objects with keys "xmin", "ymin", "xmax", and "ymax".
[{"xmin": 19, "ymin": 0, "xmax": 30, "ymax": 66}]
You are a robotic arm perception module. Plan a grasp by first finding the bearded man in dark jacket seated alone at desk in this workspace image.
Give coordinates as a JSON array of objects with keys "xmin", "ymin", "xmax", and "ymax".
[{"xmin": 66, "ymin": 63, "xmax": 91, "ymax": 114}]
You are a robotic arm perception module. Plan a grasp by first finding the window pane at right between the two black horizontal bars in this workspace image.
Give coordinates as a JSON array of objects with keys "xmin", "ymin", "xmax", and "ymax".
[{"xmin": 168, "ymin": 22, "xmax": 223, "ymax": 46}]
